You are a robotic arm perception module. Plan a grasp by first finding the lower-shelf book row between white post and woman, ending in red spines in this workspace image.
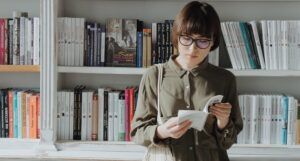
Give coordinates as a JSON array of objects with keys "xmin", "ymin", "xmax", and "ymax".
[{"xmin": 57, "ymin": 86, "xmax": 137, "ymax": 141}]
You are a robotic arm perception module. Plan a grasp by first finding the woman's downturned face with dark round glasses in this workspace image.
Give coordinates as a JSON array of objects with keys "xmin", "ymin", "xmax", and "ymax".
[{"xmin": 178, "ymin": 34, "xmax": 213, "ymax": 66}]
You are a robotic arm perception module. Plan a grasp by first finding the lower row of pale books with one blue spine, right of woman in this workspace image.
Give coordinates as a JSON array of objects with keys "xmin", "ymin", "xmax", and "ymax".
[{"xmin": 238, "ymin": 94, "xmax": 300, "ymax": 145}]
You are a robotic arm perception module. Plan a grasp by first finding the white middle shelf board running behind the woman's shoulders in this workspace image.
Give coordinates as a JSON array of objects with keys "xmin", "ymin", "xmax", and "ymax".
[{"xmin": 58, "ymin": 66, "xmax": 300, "ymax": 77}]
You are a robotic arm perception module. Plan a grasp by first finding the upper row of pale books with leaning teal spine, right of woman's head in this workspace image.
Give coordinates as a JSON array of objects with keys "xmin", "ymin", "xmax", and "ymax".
[{"xmin": 221, "ymin": 20, "xmax": 300, "ymax": 70}]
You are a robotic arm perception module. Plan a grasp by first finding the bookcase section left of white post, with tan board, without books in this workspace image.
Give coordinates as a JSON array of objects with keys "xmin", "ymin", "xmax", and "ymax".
[{"xmin": 0, "ymin": 0, "xmax": 41, "ymax": 160}]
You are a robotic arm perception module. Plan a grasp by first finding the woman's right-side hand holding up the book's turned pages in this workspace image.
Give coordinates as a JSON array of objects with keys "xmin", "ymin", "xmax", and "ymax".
[{"xmin": 210, "ymin": 103, "xmax": 232, "ymax": 130}]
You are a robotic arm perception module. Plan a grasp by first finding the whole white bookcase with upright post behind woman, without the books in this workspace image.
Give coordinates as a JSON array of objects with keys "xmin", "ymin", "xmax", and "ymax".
[{"xmin": 0, "ymin": 0, "xmax": 300, "ymax": 161}]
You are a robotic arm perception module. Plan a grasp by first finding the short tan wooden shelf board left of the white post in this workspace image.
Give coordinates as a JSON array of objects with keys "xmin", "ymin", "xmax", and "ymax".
[{"xmin": 0, "ymin": 65, "xmax": 40, "ymax": 73}]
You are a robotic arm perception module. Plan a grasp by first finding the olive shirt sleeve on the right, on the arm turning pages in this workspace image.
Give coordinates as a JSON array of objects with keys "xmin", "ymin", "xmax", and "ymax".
[{"xmin": 214, "ymin": 76, "xmax": 243, "ymax": 150}]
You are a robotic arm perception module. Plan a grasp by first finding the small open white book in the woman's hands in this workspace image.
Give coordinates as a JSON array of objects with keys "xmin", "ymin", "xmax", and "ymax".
[{"xmin": 178, "ymin": 95, "xmax": 223, "ymax": 131}]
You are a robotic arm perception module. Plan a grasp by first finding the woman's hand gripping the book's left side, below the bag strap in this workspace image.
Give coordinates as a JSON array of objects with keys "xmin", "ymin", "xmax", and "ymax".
[{"xmin": 156, "ymin": 117, "xmax": 192, "ymax": 139}]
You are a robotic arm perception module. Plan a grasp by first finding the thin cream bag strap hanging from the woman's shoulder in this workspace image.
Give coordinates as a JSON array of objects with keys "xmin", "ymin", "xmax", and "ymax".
[{"xmin": 156, "ymin": 64, "xmax": 163, "ymax": 125}]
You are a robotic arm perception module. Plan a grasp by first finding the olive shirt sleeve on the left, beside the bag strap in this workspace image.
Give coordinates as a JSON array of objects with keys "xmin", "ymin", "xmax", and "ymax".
[{"xmin": 130, "ymin": 67, "xmax": 158, "ymax": 146}]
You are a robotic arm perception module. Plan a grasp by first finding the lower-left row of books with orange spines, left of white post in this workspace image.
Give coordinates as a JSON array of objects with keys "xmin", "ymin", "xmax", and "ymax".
[{"xmin": 0, "ymin": 89, "xmax": 40, "ymax": 139}]
